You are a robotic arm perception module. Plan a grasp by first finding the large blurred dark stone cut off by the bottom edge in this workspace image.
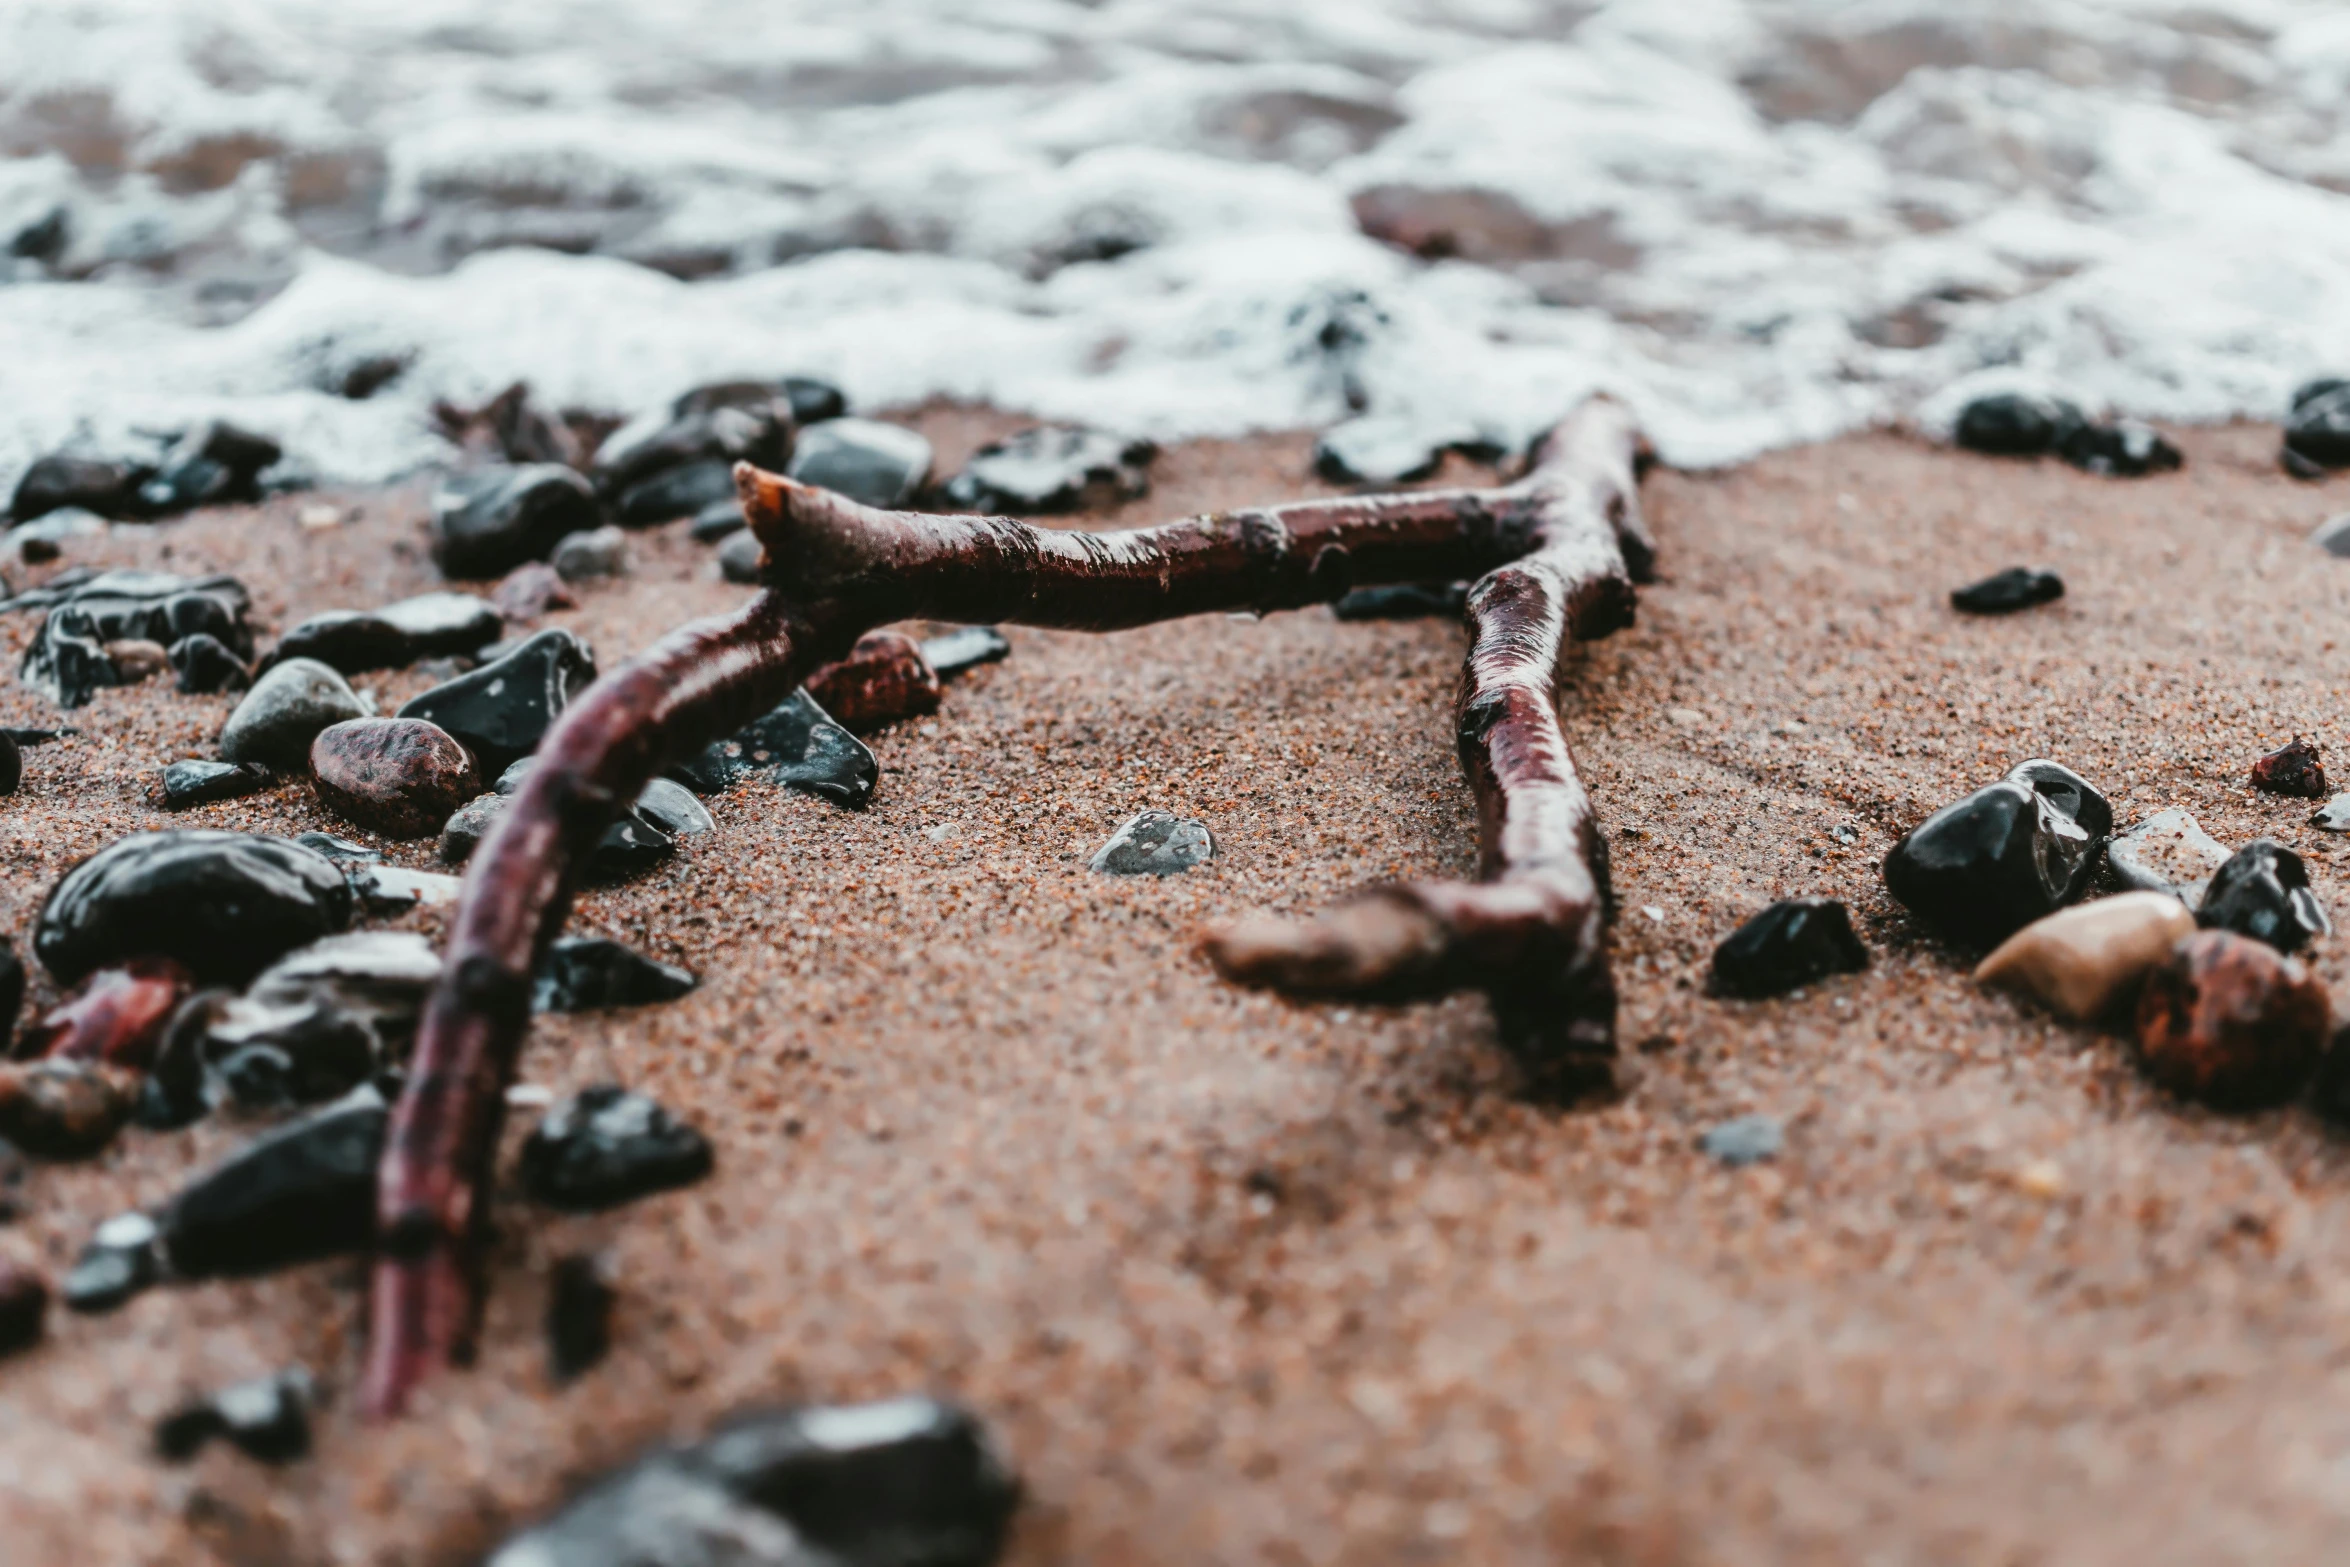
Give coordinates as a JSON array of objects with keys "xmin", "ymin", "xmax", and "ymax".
[{"xmin": 486, "ymin": 1398, "xmax": 1020, "ymax": 1567}]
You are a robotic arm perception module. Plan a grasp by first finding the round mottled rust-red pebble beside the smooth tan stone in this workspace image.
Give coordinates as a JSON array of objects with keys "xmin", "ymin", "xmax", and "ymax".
[{"xmin": 2139, "ymin": 930, "xmax": 2331, "ymax": 1109}]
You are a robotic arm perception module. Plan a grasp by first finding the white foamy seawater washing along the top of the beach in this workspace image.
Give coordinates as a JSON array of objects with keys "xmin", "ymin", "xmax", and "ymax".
[{"xmin": 0, "ymin": 0, "xmax": 2350, "ymax": 486}]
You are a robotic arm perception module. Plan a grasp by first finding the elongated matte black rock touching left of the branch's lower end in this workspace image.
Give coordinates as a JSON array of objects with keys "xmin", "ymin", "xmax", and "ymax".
[{"xmin": 160, "ymin": 1085, "xmax": 390, "ymax": 1278}]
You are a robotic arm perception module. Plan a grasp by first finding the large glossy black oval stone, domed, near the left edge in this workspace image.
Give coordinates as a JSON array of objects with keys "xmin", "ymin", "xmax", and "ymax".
[{"xmin": 33, "ymin": 829, "xmax": 350, "ymax": 984}]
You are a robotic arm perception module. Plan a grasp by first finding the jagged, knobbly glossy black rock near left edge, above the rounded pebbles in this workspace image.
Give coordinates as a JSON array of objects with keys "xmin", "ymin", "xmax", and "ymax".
[{"xmin": 7, "ymin": 571, "xmax": 254, "ymax": 707}]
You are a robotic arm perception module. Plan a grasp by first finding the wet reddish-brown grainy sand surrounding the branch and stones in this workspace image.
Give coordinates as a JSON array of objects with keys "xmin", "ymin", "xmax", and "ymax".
[{"xmin": 0, "ymin": 409, "xmax": 2350, "ymax": 1567}]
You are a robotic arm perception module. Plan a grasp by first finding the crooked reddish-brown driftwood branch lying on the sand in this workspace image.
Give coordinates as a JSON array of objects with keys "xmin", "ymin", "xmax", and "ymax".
[{"xmin": 362, "ymin": 399, "xmax": 1654, "ymax": 1417}]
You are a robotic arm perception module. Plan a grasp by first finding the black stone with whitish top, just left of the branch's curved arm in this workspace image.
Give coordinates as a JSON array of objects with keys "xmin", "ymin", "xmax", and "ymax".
[{"xmin": 200, "ymin": 930, "xmax": 439, "ymax": 1109}]
